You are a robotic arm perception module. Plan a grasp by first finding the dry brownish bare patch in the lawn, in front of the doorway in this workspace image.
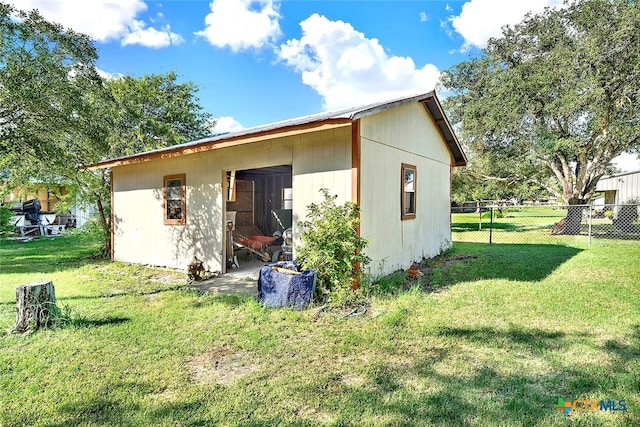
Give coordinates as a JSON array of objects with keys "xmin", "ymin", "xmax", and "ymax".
[{"xmin": 185, "ymin": 347, "xmax": 258, "ymax": 385}]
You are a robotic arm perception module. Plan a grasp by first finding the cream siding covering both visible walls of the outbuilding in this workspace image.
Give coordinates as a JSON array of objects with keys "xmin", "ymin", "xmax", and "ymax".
[{"xmin": 113, "ymin": 103, "xmax": 451, "ymax": 275}]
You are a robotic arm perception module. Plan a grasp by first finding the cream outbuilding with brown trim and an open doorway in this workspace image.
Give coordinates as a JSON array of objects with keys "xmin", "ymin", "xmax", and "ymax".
[{"xmin": 93, "ymin": 92, "xmax": 466, "ymax": 276}]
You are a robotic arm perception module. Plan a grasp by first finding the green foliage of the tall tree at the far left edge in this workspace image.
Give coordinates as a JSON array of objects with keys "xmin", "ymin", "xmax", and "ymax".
[{"xmin": 0, "ymin": 4, "xmax": 101, "ymax": 184}]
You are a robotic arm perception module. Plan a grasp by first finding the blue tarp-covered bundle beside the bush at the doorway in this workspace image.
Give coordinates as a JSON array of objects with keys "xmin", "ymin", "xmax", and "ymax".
[{"xmin": 258, "ymin": 261, "xmax": 316, "ymax": 310}]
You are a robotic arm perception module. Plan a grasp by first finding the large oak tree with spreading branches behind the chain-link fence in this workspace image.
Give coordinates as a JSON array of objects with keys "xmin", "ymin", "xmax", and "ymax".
[{"xmin": 442, "ymin": 0, "xmax": 640, "ymax": 233}]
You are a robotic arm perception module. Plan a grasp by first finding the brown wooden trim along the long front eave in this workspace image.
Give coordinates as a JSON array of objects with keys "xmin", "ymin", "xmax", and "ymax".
[{"xmin": 86, "ymin": 118, "xmax": 352, "ymax": 170}]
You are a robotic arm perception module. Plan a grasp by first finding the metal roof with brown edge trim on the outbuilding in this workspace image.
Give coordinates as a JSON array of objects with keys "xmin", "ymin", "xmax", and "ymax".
[{"xmin": 89, "ymin": 91, "xmax": 467, "ymax": 169}]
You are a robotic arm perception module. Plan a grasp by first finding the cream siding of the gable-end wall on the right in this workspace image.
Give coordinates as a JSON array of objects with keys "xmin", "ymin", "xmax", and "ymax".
[{"xmin": 360, "ymin": 104, "xmax": 451, "ymax": 276}]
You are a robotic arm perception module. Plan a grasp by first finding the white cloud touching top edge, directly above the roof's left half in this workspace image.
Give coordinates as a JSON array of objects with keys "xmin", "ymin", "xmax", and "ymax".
[{"xmin": 195, "ymin": 0, "xmax": 280, "ymax": 52}]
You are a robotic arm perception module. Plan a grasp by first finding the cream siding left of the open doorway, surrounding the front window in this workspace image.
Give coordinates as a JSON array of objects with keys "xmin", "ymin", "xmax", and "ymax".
[{"xmin": 113, "ymin": 155, "xmax": 222, "ymax": 268}]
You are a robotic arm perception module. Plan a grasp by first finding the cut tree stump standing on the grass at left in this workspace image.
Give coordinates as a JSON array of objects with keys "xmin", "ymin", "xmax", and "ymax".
[{"xmin": 11, "ymin": 281, "xmax": 57, "ymax": 333}]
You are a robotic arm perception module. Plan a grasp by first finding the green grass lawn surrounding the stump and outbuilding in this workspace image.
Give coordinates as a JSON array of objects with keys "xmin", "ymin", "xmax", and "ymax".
[{"xmin": 0, "ymin": 235, "xmax": 640, "ymax": 426}]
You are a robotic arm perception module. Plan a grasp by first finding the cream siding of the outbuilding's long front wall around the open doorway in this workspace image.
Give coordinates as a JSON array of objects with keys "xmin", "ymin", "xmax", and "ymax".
[{"xmin": 113, "ymin": 126, "xmax": 351, "ymax": 271}]
